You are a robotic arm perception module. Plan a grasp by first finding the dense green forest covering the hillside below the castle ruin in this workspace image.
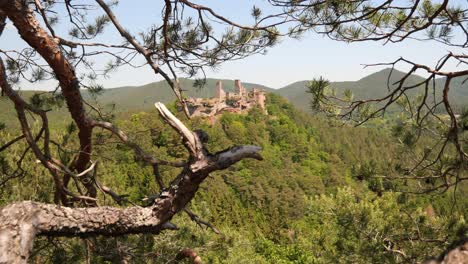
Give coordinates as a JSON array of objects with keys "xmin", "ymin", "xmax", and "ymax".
[{"xmin": 0, "ymin": 95, "xmax": 468, "ymax": 263}]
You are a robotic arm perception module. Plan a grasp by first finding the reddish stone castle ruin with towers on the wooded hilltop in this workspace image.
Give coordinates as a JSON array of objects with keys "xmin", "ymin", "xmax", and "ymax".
[{"xmin": 186, "ymin": 80, "xmax": 266, "ymax": 117}]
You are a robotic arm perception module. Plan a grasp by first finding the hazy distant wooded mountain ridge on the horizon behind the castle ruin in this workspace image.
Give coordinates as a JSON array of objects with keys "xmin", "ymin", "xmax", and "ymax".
[{"xmin": 0, "ymin": 69, "xmax": 468, "ymax": 127}]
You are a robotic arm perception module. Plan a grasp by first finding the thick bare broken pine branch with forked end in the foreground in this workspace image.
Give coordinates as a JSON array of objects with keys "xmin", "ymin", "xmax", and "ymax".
[{"xmin": 0, "ymin": 103, "xmax": 262, "ymax": 264}]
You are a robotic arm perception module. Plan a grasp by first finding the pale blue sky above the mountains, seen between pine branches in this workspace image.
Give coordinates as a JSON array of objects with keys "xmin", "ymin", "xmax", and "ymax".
[{"xmin": 0, "ymin": 0, "xmax": 464, "ymax": 89}]
